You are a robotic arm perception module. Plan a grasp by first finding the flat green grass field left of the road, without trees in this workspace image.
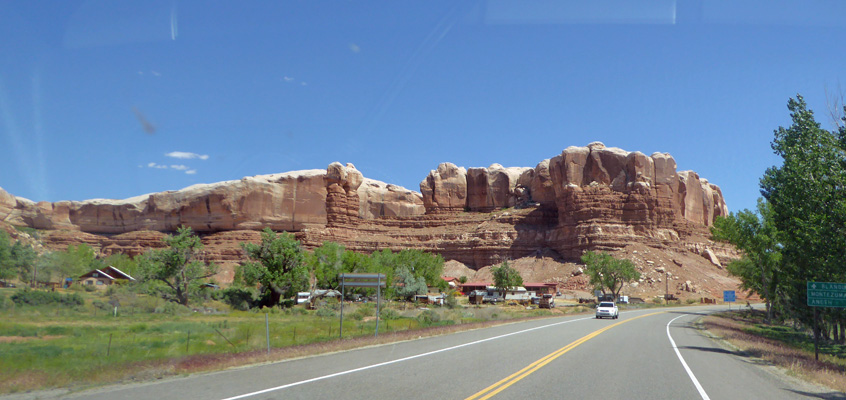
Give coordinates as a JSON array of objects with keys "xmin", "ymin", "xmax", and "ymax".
[{"xmin": 0, "ymin": 289, "xmax": 560, "ymax": 393}]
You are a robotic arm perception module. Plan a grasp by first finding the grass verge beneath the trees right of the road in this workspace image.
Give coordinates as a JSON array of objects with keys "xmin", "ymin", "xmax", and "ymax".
[{"xmin": 702, "ymin": 310, "xmax": 846, "ymax": 392}]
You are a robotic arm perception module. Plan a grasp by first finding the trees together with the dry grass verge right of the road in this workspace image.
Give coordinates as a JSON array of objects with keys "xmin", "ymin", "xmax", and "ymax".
[{"xmin": 706, "ymin": 96, "xmax": 846, "ymax": 391}]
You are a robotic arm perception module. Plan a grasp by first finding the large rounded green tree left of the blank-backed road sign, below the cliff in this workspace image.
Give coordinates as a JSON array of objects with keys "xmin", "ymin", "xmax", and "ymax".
[{"xmin": 236, "ymin": 228, "xmax": 309, "ymax": 306}]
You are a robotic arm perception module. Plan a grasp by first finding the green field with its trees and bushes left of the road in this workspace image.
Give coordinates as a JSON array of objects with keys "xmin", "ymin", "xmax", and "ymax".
[{"xmin": 0, "ymin": 228, "xmax": 589, "ymax": 393}]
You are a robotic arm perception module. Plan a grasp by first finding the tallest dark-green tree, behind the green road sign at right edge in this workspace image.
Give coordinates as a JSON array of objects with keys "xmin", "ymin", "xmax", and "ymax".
[{"xmin": 761, "ymin": 96, "xmax": 846, "ymax": 326}]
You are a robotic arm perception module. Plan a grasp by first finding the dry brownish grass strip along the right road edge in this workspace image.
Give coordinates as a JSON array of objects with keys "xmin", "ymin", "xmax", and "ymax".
[{"xmin": 703, "ymin": 314, "xmax": 846, "ymax": 392}]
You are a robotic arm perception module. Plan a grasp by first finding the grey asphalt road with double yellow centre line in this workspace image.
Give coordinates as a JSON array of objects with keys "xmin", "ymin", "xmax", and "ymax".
[{"xmin": 4, "ymin": 307, "xmax": 846, "ymax": 400}]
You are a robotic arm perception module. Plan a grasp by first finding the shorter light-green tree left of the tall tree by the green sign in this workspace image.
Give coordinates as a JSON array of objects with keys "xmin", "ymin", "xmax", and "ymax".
[{"xmin": 711, "ymin": 199, "xmax": 781, "ymax": 321}]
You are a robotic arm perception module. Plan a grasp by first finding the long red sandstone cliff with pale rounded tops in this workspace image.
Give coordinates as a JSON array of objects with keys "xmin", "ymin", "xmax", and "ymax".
[{"xmin": 0, "ymin": 142, "xmax": 728, "ymax": 282}]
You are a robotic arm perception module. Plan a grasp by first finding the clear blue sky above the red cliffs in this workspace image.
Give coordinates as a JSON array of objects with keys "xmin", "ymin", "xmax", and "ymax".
[{"xmin": 0, "ymin": 0, "xmax": 846, "ymax": 216}]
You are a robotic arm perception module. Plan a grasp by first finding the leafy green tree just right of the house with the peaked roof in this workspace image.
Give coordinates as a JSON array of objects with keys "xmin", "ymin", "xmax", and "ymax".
[{"xmin": 138, "ymin": 227, "xmax": 217, "ymax": 306}]
